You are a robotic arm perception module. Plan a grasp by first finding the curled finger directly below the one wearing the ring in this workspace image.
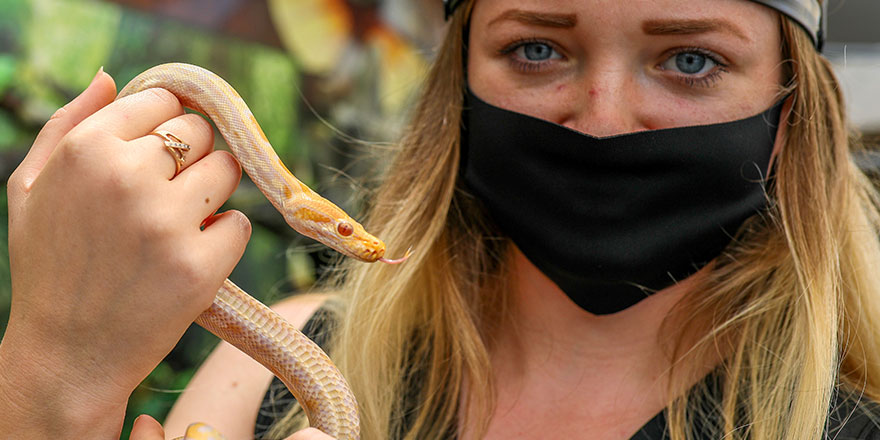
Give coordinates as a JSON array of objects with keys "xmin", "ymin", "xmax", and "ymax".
[{"xmin": 171, "ymin": 151, "xmax": 241, "ymax": 223}]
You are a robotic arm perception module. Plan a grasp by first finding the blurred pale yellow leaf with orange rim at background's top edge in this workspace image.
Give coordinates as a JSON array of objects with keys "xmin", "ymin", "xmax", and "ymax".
[{"xmin": 269, "ymin": 0, "xmax": 354, "ymax": 75}]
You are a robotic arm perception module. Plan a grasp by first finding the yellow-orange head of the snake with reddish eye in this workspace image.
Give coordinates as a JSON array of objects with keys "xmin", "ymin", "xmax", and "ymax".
[{"xmin": 283, "ymin": 200, "xmax": 385, "ymax": 263}]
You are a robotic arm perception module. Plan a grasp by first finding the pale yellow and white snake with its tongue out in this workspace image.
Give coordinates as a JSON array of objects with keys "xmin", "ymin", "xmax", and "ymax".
[{"xmin": 117, "ymin": 63, "xmax": 409, "ymax": 439}]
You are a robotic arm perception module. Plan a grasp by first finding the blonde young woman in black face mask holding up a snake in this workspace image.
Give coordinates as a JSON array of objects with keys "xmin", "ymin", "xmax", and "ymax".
[{"xmin": 0, "ymin": 0, "xmax": 880, "ymax": 440}]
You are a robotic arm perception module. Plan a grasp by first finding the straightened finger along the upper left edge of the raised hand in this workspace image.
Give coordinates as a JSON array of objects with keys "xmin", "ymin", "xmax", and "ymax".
[{"xmin": 8, "ymin": 68, "xmax": 116, "ymax": 204}]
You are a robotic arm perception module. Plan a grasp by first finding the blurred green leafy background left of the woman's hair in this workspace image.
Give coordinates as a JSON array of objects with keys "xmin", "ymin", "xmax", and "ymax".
[{"xmin": 0, "ymin": 0, "xmax": 442, "ymax": 438}]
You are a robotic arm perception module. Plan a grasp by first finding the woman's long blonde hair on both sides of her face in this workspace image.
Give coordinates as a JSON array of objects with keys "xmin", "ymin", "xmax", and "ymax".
[{"xmin": 273, "ymin": 2, "xmax": 880, "ymax": 440}]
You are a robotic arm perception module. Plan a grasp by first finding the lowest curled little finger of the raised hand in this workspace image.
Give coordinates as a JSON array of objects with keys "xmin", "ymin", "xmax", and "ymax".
[{"xmin": 194, "ymin": 211, "xmax": 251, "ymax": 273}]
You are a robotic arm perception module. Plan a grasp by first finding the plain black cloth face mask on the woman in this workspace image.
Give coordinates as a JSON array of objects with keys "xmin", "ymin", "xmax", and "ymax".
[{"xmin": 461, "ymin": 90, "xmax": 782, "ymax": 315}]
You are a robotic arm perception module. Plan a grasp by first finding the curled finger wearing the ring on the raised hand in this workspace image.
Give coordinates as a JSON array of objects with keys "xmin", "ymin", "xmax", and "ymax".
[{"xmin": 129, "ymin": 113, "xmax": 214, "ymax": 180}]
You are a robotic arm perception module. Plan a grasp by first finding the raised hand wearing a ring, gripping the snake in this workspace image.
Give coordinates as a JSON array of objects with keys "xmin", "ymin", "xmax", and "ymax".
[{"xmin": 0, "ymin": 68, "xmax": 250, "ymax": 437}]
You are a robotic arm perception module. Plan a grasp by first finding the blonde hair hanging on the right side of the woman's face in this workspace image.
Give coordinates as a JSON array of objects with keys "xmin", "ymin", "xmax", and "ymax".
[{"xmin": 667, "ymin": 12, "xmax": 880, "ymax": 440}]
